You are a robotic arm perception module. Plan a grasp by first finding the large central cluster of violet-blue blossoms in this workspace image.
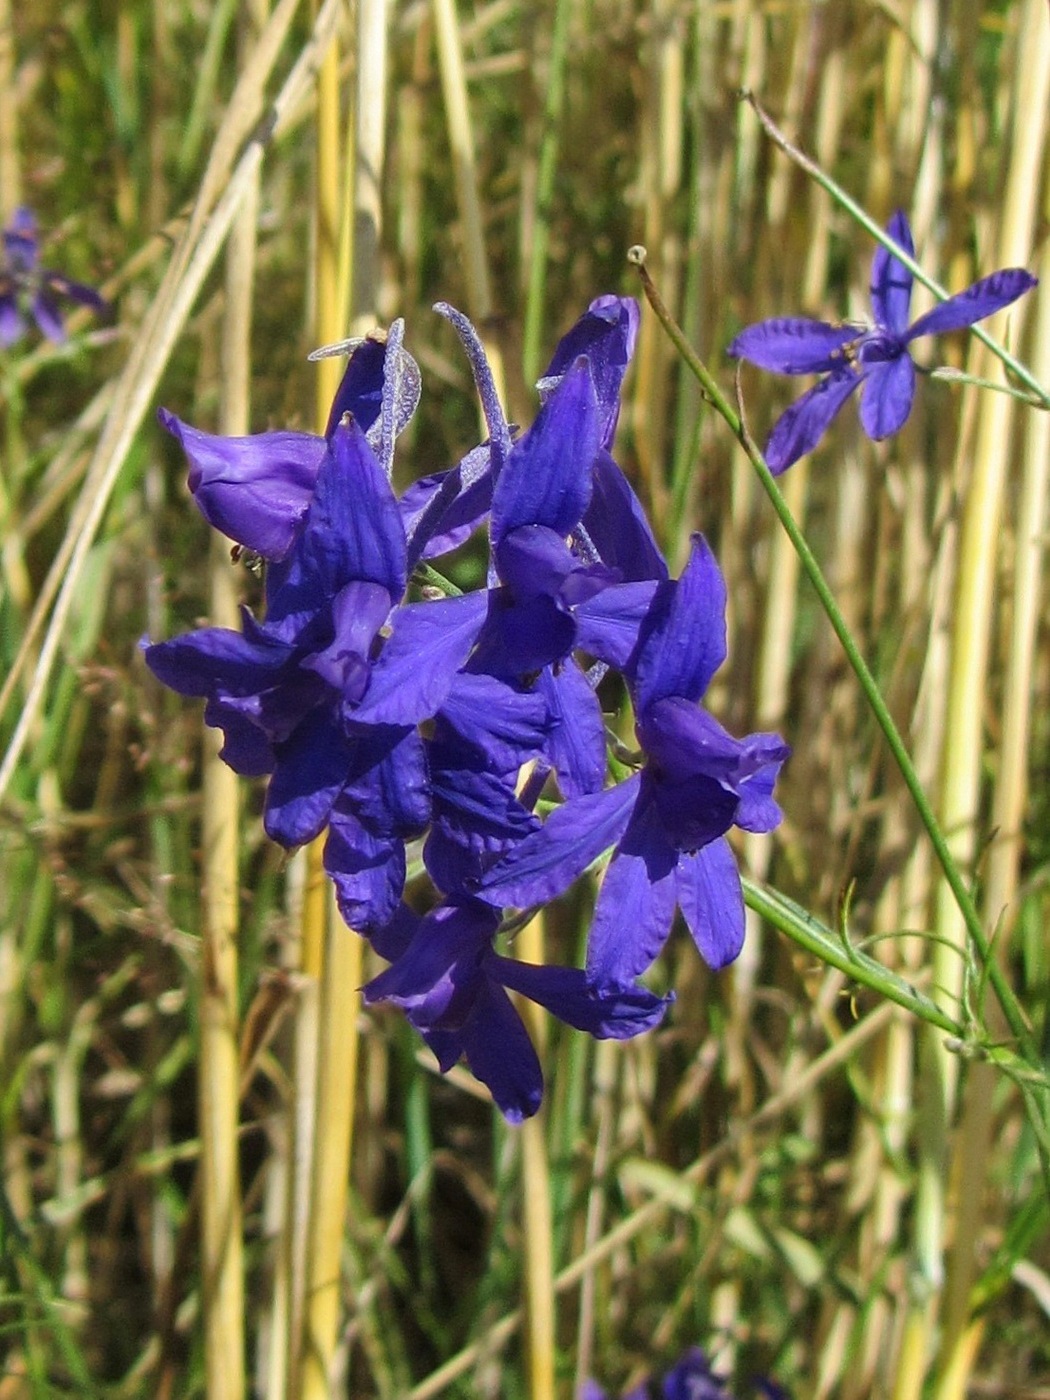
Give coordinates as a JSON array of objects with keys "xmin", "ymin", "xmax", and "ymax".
[{"xmin": 146, "ymin": 295, "xmax": 788, "ymax": 1121}]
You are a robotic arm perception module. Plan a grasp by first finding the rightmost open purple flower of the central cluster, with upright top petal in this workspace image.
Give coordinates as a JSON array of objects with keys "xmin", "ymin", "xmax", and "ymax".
[{"xmin": 477, "ymin": 536, "xmax": 790, "ymax": 986}]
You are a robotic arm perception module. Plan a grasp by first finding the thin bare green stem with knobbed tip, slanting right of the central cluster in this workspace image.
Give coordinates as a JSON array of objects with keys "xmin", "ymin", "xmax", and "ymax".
[{"xmin": 627, "ymin": 246, "xmax": 1040, "ymax": 1064}]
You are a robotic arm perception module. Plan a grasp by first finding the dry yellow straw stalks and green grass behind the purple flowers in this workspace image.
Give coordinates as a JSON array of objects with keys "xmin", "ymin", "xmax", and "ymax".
[{"xmin": 0, "ymin": 0, "xmax": 1050, "ymax": 1400}]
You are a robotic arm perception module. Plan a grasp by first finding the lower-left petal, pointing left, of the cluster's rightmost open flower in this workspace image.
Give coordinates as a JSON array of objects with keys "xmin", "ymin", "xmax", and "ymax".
[{"xmin": 477, "ymin": 773, "xmax": 641, "ymax": 909}]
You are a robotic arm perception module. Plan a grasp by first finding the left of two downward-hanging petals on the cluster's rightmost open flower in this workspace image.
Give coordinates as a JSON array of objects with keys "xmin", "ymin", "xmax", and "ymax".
[{"xmin": 587, "ymin": 805, "xmax": 678, "ymax": 987}]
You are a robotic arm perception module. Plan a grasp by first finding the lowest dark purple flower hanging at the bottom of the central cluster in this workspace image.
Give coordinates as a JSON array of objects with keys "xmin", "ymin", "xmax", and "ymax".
[{"xmin": 364, "ymin": 900, "xmax": 671, "ymax": 1123}]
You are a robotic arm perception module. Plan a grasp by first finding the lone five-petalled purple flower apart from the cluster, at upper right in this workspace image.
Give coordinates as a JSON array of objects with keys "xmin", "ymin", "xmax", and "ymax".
[{"xmin": 727, "ymin": 210, "xmax": 1036, "ymax": 476}]
